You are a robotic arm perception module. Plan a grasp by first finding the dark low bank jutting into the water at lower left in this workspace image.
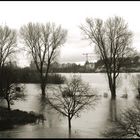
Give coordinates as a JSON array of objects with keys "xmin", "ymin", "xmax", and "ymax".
[{"xmin": 0, "ymin": 107, "xmax": 45, "ymax": 131}]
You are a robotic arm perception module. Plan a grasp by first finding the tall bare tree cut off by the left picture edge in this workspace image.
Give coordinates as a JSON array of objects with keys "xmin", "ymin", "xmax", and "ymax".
[{"xmin": 0, "ymin": 26, "xmax": 17, "ymax": 99}]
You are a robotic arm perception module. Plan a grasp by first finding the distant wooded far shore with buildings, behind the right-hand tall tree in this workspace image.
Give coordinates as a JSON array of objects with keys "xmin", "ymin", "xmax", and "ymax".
[{"xmin": 51, "ymin": 56, "xmax": 140, "ymax": 73}]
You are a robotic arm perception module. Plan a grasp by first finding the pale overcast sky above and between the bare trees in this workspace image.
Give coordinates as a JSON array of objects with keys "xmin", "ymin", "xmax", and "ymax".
[{"xmin": 0, "ymin": 1, "xmax": 140, "ymax": 66}]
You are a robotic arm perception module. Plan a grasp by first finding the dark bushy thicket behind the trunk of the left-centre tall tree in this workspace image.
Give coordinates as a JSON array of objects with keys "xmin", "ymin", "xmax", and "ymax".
[{"xmin": 14, "ymin": 67, "xmax": 66, "ymax": 84}]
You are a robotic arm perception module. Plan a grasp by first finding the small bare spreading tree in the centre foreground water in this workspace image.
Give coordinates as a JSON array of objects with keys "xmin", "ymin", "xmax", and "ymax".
[{"xmin": 47, "ymin": 75, "xmax": 99, "ymax": 137}]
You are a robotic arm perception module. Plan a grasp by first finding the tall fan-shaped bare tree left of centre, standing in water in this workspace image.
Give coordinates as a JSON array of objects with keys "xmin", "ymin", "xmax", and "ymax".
[{"xmin": 20, "ymin": 23, "xmax": 67, "ymax": 95}]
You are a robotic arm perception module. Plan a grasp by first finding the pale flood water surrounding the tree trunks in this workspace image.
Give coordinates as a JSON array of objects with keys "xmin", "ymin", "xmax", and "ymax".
[{"xmin": 0, "ymin": 73, "xmax": 138, "ymax": 138}]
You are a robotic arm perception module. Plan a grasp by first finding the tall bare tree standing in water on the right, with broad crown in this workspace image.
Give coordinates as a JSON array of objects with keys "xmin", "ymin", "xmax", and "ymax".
[{"xmin": 80, "ymin": 17, "xmax": 132, "ymax": 99}]
